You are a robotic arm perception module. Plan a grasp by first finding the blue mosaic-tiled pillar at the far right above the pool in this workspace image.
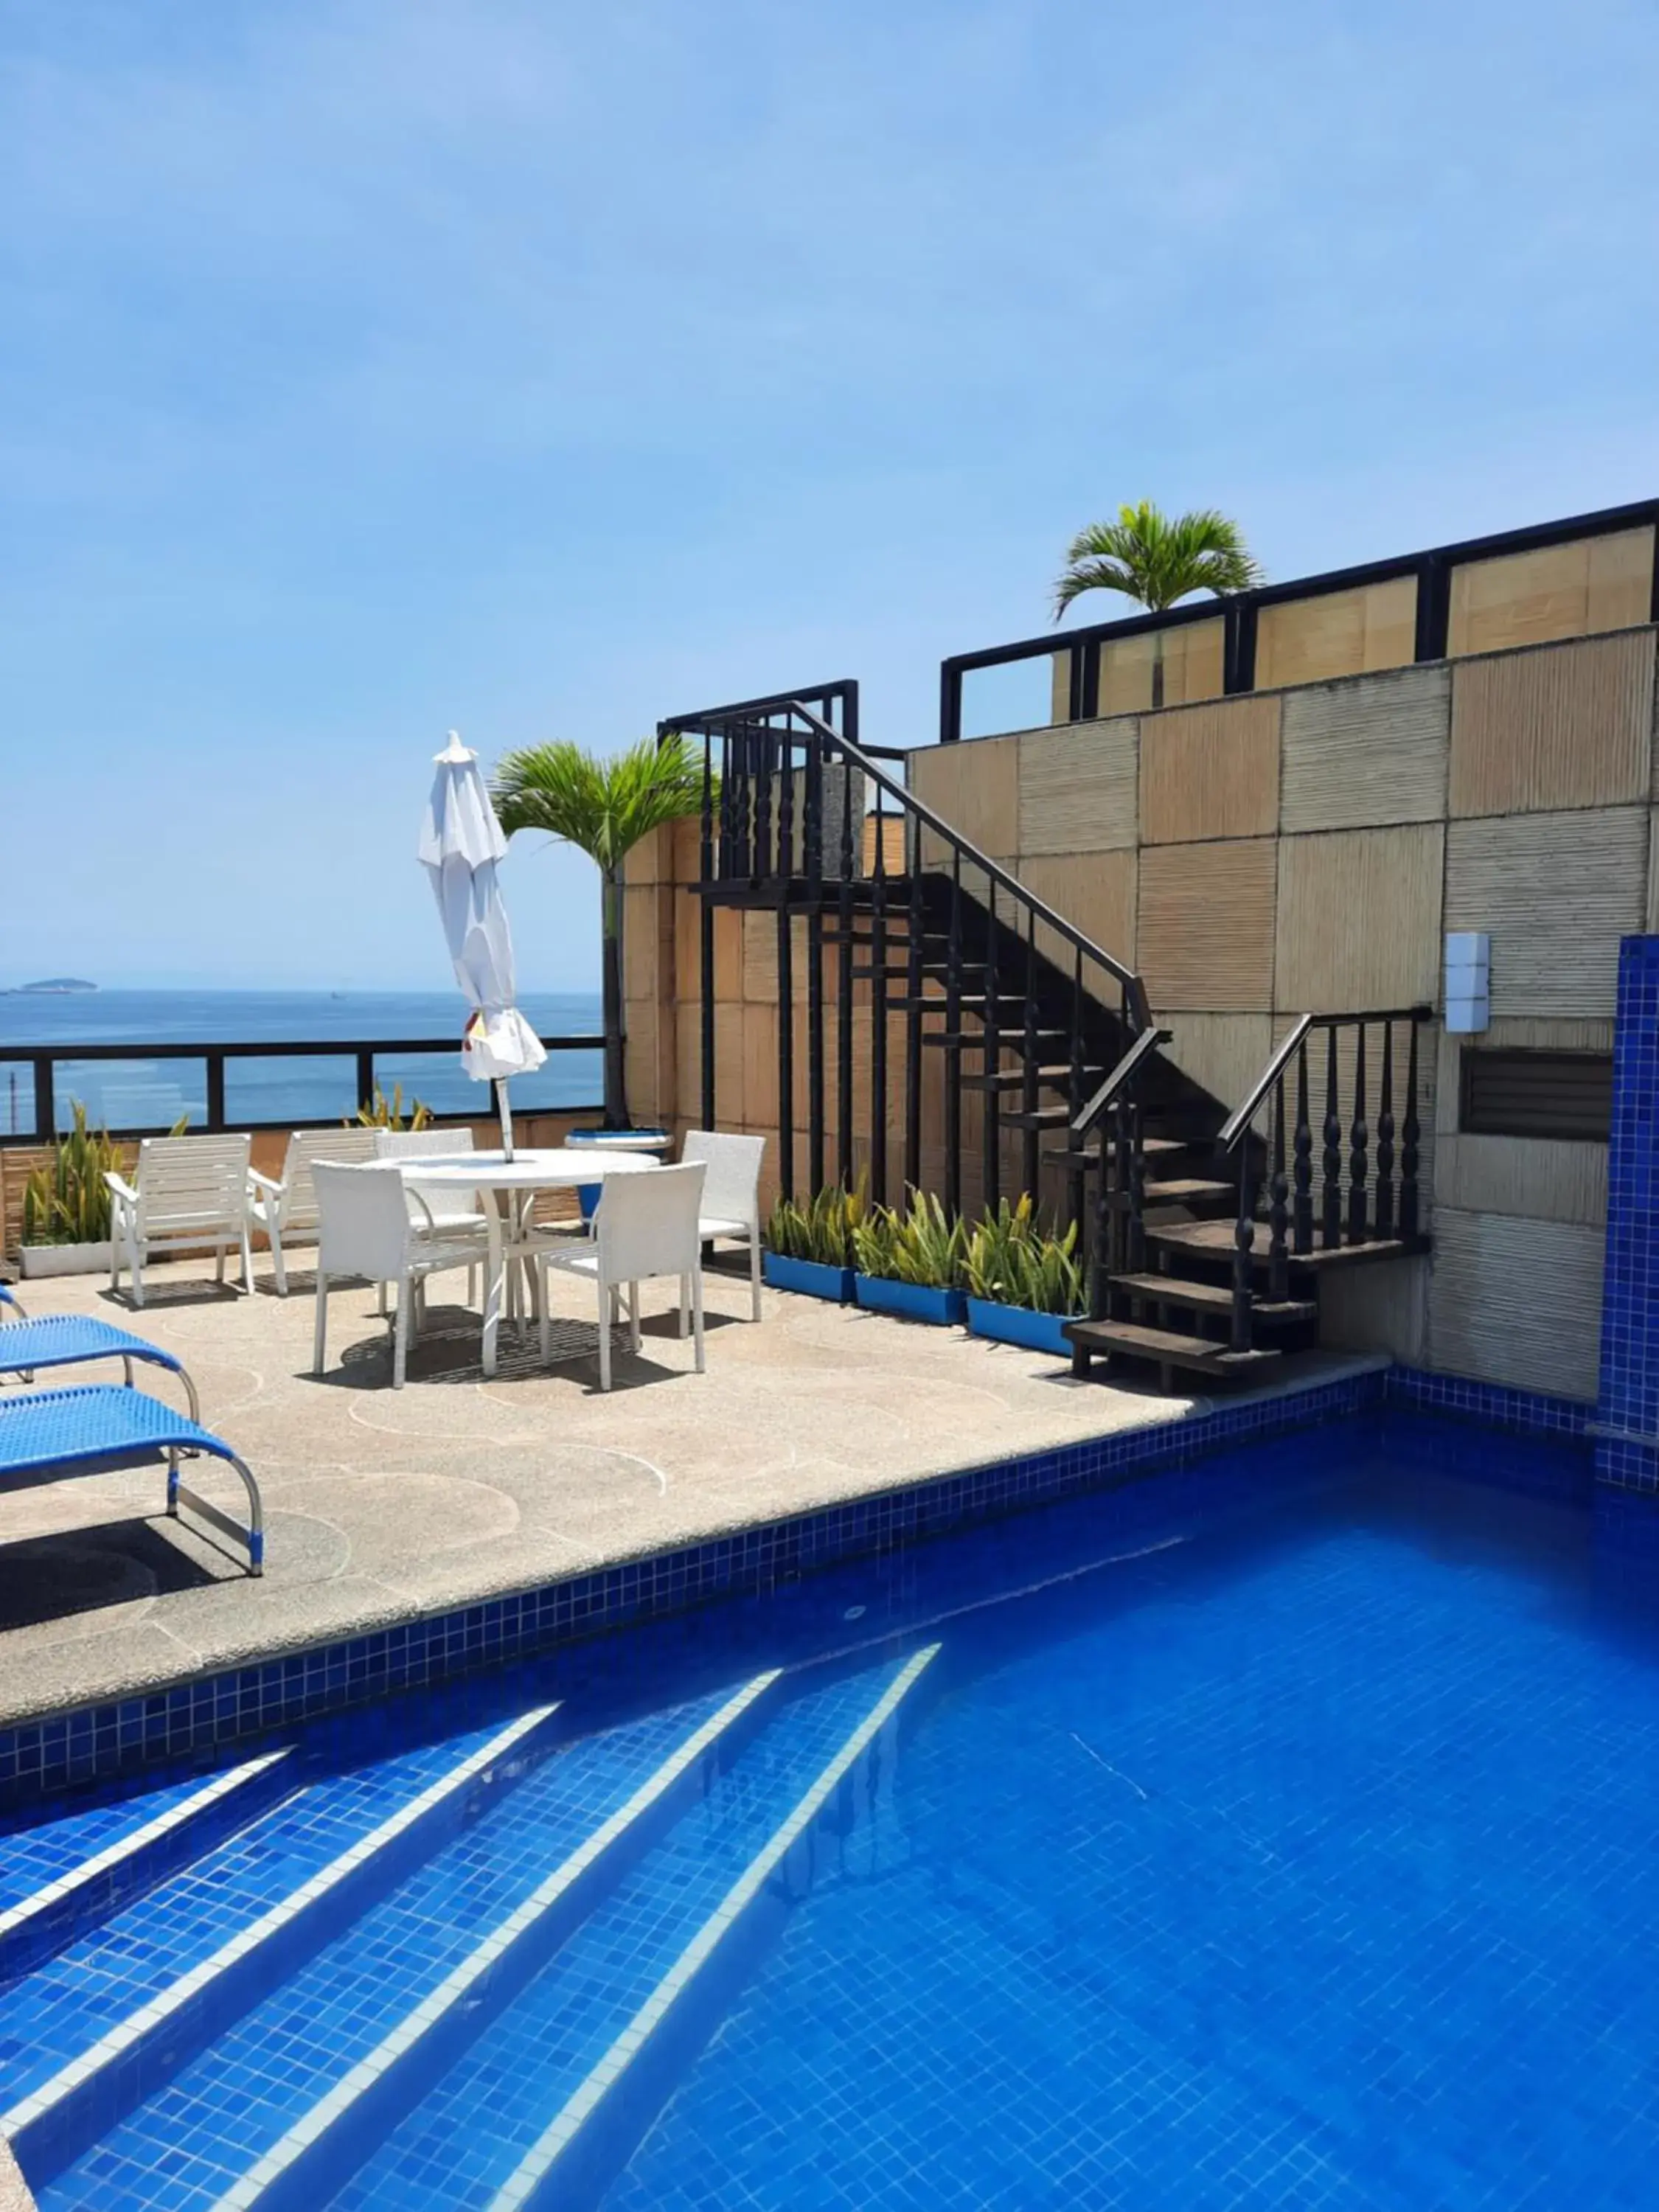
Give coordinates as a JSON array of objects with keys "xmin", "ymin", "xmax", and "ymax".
[{"xmin": 1597, "ymin": 936, "xmax": 1659, "ymax": 1491}]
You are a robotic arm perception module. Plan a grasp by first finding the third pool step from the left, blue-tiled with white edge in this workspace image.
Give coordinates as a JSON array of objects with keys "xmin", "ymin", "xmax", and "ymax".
[{"xmin": 42, "ymin": 1672, "xmax": 779, "ymax": 2208}]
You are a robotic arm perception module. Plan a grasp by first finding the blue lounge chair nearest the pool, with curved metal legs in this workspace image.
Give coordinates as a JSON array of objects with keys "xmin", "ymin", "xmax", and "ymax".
[{"xmin": 0, "ymin": 1380, "xmax": 265, "ymax": 1575}]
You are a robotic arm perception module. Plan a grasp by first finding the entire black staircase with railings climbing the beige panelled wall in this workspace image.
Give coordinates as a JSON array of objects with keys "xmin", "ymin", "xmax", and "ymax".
[{"xmin": 659, "ymin": 681, "xmax": 1429, "ymax": 1382}]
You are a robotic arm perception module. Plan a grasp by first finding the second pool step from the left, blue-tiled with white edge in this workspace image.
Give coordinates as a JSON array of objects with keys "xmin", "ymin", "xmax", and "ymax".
[{"xmin": 0, "ymin": 1703, "xmax": 557, "ymax": 2192}]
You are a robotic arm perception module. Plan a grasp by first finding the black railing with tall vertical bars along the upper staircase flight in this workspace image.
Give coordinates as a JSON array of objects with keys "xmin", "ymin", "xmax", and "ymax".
[{"xmin": 659, "ymin": 679, "xmax": 1150, "ymax": 1217}]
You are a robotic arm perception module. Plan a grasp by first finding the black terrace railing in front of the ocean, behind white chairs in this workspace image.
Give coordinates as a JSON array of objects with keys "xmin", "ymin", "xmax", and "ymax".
[{"xmin": 0, "ymin": 1037, "xmax": 604, "ymax": 1146}]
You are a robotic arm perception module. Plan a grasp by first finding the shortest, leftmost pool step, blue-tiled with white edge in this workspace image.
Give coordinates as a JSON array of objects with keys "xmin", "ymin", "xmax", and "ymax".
[{"xmin": 0, "ymin": 1747, "xmax": 299, "ymax": 1982}]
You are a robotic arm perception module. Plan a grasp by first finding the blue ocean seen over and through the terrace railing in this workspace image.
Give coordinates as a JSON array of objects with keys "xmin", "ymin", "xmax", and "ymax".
[{"xmin": 0, "ymin": 991, "xmax": 604, "ymax": 1137}]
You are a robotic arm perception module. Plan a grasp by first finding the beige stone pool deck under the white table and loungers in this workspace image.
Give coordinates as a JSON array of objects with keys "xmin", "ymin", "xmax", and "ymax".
[{"xmin": 0, "ymin": 1263, "xmax": 1387, "ymax": 1723}]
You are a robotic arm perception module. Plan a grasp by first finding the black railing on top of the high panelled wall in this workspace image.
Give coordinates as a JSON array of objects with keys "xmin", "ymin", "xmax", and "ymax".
[{"xmin": 938, "ymin": 500, "xmax": 1659, "ymax": 745}]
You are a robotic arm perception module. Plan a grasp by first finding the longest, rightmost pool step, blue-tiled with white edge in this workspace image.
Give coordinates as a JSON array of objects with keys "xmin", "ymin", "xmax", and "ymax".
[{"xmin": 330, "ymin": 1646, "xmax": 938, "ymax": 2212}]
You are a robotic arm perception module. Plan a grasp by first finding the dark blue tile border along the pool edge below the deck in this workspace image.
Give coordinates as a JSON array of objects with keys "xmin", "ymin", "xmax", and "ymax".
[{"xmin": 0, "ymin": 1369, "xmax": 1385, "ymax": 1805}]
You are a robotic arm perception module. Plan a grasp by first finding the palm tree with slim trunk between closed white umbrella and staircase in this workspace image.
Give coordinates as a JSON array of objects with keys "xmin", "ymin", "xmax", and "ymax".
[{"xmin": 491, "ymin": 732, "xmax": 703, "ymax": 1128}]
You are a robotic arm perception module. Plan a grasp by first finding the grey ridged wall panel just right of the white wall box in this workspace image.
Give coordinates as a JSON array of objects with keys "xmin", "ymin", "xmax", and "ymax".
[{"xmin": 1444, "ymin": 807, "xmax": 1648, "ymax": 1018}]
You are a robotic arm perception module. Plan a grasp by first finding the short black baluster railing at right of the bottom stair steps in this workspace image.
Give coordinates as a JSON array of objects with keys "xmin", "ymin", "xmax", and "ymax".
[{"xmin": 1219, "ymin": 1006, "xmax": 1433, "ymax": 1352}]
